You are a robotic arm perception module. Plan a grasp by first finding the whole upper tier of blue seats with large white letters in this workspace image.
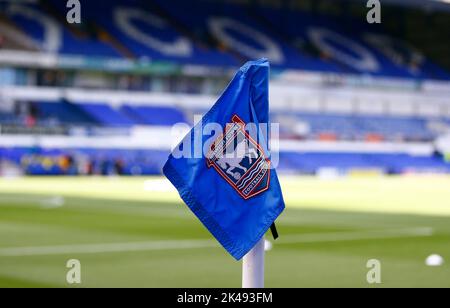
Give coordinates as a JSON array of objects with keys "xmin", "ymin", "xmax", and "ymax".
[{"xmin": 2, "ymin": 0, "xmax": 450, "ymax": 80}]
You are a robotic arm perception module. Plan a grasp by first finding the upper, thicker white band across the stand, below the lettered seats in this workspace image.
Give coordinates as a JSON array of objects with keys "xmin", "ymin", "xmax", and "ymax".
[{"xmin": 0, "ymin": 81, "xmax": 450, "ymax": 118}]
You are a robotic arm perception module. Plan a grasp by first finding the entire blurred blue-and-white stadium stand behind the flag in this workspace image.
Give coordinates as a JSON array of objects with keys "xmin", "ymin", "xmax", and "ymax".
[{"xmin": 0, "ymin": 0, "xmax": 450, "ymax": 175}]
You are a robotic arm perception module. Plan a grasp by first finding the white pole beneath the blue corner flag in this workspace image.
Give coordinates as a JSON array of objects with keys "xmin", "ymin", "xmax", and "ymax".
[{"xmin": 242, "ymin": 236, "xmax": 265, "ymax": 289}]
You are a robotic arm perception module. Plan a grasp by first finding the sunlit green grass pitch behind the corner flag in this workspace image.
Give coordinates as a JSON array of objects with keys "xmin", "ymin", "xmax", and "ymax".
[{"xmin": 0, "ymin": 177, "xmax": 450, "ymax": 287}]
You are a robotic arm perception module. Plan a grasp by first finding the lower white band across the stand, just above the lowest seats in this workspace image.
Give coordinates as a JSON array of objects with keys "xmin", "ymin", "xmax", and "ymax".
[{"xmin": 0, "ymin": 131, "xmax": 435, "ymax": 156}]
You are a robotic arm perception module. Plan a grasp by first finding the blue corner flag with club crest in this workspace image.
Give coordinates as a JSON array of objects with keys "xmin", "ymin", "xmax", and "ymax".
[{"xmin": 163, "ymin": 59, "xmax": 284, "ymax": 260}]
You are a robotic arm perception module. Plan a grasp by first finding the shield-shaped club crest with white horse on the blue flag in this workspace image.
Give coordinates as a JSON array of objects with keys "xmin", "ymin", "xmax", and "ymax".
[{"xmin": 206, "ymin": 115, "xmax": 270, "ymax": 200}]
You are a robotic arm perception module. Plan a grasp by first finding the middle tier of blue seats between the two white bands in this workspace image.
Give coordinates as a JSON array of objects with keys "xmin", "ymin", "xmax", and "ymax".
[{"xmin": 0, "ymin": 102, "xmax": 448, "ymax": 141}]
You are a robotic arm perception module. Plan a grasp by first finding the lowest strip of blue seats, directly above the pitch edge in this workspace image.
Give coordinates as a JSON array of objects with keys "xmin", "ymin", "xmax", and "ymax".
[{"xmin": 0, "ymin": 147, "xmax": 450, "ymax": 175}]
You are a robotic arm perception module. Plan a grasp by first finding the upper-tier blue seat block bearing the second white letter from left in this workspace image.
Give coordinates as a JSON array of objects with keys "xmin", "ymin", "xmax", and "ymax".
[{"xmin": 77, "ymin": 1, "xmax": 238, "ymax": 66}]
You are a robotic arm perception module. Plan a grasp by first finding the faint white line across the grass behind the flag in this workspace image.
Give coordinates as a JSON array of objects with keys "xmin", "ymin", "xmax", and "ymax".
[{"xmin": 0, "ymin": 228, "xmax": 433, "ymax": 257}]
